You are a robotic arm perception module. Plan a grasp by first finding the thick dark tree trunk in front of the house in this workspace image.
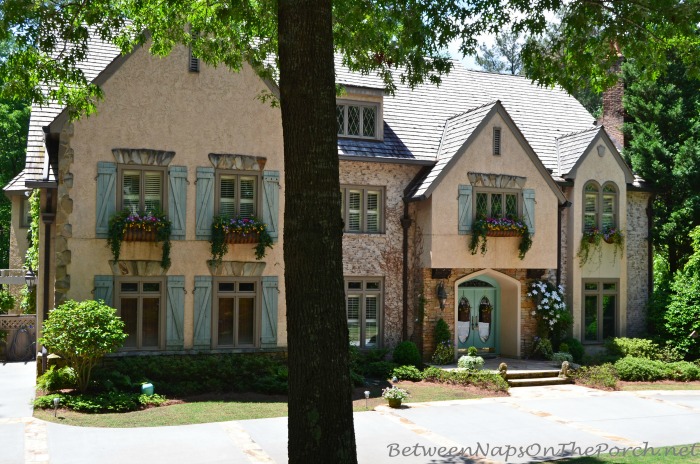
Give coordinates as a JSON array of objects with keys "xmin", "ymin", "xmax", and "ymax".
[{"xmin": 278, "ymin": 0, "xmax": 357, "ymax": 464}]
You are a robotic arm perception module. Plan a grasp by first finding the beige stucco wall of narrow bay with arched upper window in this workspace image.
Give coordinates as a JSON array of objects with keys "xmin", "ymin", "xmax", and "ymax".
[{"xmin": 566, "ymin": 138, "xmax": 628, "ymax": 339}]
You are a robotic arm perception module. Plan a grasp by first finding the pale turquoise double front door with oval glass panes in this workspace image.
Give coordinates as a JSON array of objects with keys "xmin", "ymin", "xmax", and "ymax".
[{"xmin": 457, "ymin": 279, "xmax": 498, "ymax": 354}]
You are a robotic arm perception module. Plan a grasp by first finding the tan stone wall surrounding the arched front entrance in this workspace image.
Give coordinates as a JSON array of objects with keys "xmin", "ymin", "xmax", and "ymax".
[{"xmin": 423, "ymin": 269, "xmax": 556, "ymax": 361}]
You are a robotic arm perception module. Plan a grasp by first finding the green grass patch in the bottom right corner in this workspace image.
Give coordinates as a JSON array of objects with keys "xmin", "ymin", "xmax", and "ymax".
[{"xmin": 556, "ymin": 443, "xmax": 700, "ymax": 464}]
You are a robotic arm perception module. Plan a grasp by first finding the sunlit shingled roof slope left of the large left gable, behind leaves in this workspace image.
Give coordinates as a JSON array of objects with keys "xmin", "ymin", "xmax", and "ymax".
[{"xmin": 24, "ymin": 36, "xmax": 120, "ymax": 183}]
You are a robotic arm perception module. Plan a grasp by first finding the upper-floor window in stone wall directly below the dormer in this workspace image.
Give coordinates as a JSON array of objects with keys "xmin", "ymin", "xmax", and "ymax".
[{"xmin": 340, "ymin": 186, "xmax": 384, "ymax": 234}]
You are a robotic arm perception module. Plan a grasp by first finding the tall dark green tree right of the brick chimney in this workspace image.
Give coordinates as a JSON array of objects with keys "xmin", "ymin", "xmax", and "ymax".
[{"xmin": 623, "ymin": 53, "xmax": 700, "ymax": 275}]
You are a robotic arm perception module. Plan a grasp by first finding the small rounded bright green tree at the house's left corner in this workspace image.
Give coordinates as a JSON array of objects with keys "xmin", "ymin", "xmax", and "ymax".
[{"xmin": 39, "ymin": 300, "xmax": 127, "ymax": 392}]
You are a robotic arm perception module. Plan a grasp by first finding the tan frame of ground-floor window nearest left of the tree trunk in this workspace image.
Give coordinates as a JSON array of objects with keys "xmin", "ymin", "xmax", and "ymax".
[{"xmin": 211, "ymin": 277, "xmax": 262, "ymax": 349}]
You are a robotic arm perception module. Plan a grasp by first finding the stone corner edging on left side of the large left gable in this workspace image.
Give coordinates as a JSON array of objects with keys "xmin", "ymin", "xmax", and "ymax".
[{"xmin": 54, "ymin": 123, "xmax": 74, "ymax": 306}]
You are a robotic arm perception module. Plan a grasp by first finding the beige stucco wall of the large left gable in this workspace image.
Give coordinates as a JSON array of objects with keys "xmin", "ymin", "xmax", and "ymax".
[{"xmin": 56, "ymin": 48, "xmax": 286, "ymax": 348}]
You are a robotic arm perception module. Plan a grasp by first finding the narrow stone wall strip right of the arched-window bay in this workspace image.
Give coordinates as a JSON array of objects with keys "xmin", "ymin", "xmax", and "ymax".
[{"xmin": 625, "ymin": 192, "xmax": 651, "ymax": 337}]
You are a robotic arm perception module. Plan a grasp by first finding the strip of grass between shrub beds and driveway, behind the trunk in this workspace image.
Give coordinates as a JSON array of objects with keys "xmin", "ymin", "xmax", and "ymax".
[{"xmin": 34, "ymin": 382, "xmax": 504, "ymax": 428}]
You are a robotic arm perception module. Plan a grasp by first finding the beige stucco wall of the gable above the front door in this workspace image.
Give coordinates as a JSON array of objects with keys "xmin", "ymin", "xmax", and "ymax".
[{"xmin": 418, "ymin": 114, "xmax": 558, "ymax": 269}]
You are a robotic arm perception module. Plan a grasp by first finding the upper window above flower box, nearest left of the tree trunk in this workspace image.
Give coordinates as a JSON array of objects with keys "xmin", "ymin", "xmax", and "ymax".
[{"xmin": 214, "ymin": 171, "xmax": 260, "ymax": 218}]
